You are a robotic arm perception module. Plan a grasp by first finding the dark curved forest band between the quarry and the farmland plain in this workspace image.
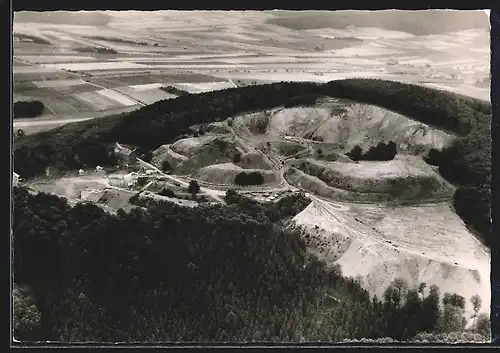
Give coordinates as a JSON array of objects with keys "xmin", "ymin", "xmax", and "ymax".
[{"xmin": 14, "ymin": 79, "xmax": 491, "ymax": 245}]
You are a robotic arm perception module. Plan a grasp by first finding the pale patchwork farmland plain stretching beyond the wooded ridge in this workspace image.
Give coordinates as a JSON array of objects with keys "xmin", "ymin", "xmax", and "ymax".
[{"xmin": 13, "ymin": 11, "xmax": 489, "ymax": 133}]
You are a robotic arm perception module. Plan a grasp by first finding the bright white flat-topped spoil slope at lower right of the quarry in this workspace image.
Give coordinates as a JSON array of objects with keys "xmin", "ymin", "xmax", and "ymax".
[{"xmin": 294, "ymin": 199, "xmax": 491, "ymax": 313}]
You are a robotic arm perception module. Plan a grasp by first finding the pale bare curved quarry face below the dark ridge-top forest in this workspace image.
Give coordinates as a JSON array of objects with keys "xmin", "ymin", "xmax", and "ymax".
[{"xmin": 270, "ymin": 103, "xmax": 454, "ymax": 153}]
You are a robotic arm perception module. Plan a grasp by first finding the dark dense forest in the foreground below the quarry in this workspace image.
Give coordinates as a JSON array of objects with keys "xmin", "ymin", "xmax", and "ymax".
[{"xmin": 13, "ymin": 188, "xmax": 490, "ymax": 342}]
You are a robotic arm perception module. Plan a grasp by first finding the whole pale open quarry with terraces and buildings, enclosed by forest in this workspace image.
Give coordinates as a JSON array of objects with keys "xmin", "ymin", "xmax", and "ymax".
[{"xmin": 21, "ymin": 99, "xmax": 490, "ymax": 320}]
